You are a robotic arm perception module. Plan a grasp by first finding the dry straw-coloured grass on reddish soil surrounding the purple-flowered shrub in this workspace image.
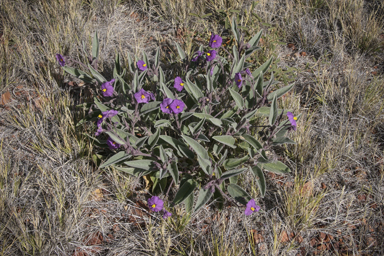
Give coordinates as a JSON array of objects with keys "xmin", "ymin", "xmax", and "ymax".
[{"xmin": 0, "ymin": 0, "xmax": 384, "ymax": 256}]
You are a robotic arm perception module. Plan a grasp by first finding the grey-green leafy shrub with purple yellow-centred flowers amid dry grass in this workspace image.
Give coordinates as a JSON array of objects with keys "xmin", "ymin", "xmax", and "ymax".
[{"xmin": 59, "ymin": 19, "xmax": 297, "ymax": 215}]
